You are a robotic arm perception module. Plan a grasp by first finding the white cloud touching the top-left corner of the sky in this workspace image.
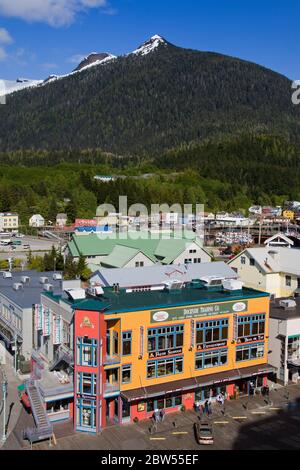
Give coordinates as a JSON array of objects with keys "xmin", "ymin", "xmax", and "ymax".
[{"xmin": 0, "ymin": 0, "xmax": 107, "ymax": 27}]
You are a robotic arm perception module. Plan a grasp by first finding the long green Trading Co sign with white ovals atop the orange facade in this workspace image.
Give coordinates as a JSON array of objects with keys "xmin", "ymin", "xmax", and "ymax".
[{"xmin": 151, "ymin": 301, "xmax": 248, "ymax": 323}]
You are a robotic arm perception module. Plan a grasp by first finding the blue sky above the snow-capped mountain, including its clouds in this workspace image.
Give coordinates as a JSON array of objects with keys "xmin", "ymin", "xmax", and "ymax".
[{"xmin": 0, "ymin": 0, "xmax": 300, "ymax": 80}]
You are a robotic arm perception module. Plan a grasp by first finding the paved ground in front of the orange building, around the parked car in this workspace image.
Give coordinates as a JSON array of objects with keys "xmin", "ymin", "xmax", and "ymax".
[{"xmin": 6, "ymin": 385, "xmax": 300, "ymax": 451}]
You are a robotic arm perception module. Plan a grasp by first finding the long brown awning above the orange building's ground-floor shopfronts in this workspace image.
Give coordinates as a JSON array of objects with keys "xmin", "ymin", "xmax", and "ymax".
[{"xmin": 121, "ymin": 364, "xmax": 276, "ymax": 402}]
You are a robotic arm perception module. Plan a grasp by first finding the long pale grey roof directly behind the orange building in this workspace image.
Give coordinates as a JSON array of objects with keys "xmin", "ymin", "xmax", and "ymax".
[{"xmin": 90, "ymin": 261, "xmax": 237, "ymax": 292}]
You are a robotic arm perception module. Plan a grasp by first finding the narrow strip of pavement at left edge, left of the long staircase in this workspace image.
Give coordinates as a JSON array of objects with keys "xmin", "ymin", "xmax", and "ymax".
[{"xmin": 0, "ymin": 354, "xmax": 22, "ymax": 448}]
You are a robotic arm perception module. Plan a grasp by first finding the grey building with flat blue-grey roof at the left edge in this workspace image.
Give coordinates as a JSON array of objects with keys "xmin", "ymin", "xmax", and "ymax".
[{"xmin": 0, "ymin": 271, "xmax": 62, "ymax": 360}]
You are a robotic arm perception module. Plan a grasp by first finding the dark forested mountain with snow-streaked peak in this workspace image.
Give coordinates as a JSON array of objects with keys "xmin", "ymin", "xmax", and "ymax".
[{"xmin": 0, "ymin": 35, "xmax": 300, "ymax": 156}]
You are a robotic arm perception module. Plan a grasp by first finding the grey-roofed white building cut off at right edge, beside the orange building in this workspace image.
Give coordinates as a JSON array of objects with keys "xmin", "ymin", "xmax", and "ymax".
[{"xmin": 269, "ymin": 298, "xmax": 300, "ymax": 385}]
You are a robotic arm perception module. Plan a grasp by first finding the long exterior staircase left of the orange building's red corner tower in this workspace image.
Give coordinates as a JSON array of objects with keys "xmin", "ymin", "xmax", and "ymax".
[{"xmin": 23, "ymin": 380, "xmax": 53, "ymax": 442}]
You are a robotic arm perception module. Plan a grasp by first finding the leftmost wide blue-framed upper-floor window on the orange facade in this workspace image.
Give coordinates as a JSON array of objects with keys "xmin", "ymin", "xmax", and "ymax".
[{"xmin": 148, "ymin": 325, "xmax": 184, "ymax": 352}]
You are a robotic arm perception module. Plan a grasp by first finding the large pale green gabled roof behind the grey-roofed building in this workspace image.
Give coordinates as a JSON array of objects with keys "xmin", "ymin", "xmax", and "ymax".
[{"xmin": 68, "ymin": 232, "xmax": 211, "ymax": 267}]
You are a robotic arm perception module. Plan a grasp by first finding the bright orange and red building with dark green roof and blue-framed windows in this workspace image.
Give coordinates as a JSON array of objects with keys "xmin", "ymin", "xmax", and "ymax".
[{"xmin": 45, "ymin": 280, "xmax": 274, "ymax": 433}]
